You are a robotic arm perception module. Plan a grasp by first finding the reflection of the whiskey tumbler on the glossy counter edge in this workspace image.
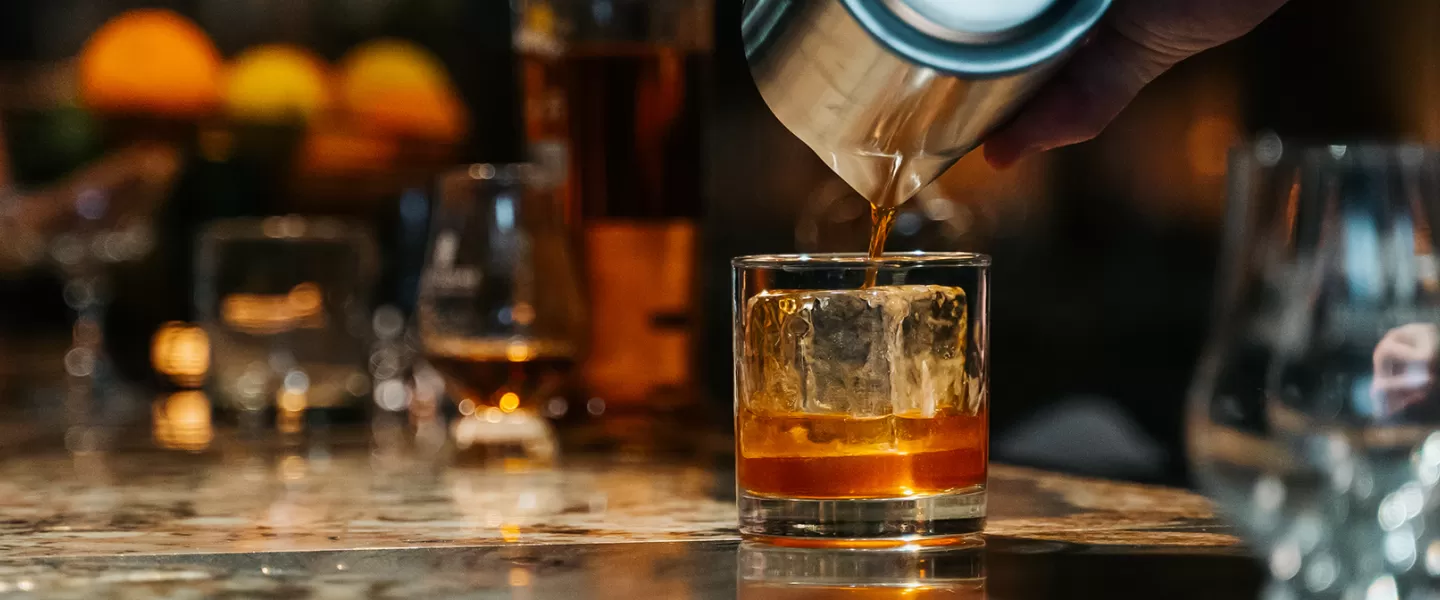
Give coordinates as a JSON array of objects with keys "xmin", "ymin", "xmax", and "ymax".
[{"xmin": 736, "ymin": 540, "xmax": 985, "ymax": 600}]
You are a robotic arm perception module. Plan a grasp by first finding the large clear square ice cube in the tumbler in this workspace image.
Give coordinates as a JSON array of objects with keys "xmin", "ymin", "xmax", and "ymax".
[{"xmin": 740, "ymin": 285, "xmax": 968, "ymax": 417}]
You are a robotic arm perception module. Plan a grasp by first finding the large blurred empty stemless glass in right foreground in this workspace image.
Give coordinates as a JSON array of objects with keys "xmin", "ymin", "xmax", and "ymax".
[{"xmin": 1189, "ymin": 137, "xmax": 1440, "ymax": 592}]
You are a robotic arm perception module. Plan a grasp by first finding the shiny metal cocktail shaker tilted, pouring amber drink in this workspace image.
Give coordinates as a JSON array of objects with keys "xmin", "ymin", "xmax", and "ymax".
[{"xmin": 743, "ymin": 0, "xmax": 1110, "ymax": 207}]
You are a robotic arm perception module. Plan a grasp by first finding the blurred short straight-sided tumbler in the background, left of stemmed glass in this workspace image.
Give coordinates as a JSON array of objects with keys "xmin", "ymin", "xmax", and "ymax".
[{"xmin": 194, "ymin": 216, "xmax": 376, "ymax": 429}]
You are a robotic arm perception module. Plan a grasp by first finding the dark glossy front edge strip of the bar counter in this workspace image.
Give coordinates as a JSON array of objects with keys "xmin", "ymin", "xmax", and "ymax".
[{"xmin": 0, "ymin": 540, "xmax": 1261, "ymax": 600}]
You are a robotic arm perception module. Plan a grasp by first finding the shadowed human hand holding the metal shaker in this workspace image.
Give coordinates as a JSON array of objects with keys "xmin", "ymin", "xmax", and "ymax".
[{"xmin": 985, "ymin": 0, "xmax": 1286, "ymax": 168}]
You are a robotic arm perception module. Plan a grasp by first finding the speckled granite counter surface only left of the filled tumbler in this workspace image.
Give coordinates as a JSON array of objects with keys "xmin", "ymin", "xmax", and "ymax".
[{"xmin": 0, "ymin": 452, "xmax": 734, "ymax": 560}]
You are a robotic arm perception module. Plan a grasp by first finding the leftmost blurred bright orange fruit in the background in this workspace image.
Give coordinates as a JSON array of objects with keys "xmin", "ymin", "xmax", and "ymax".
[{"xmin": 78, "ymin": 9, "xmax": 222, "ymax": 117}]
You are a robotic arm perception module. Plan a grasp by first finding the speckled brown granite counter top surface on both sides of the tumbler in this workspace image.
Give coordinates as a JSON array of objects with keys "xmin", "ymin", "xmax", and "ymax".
[{"xmin": 0, "ymin": 447, "xmax": 1237, "ymax": 560}]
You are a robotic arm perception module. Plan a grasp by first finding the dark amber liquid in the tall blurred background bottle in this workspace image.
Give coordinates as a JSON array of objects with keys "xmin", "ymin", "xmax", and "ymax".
[{"xmin": 526, "ymin": 42, "xmax": 707, "ymax": 413}]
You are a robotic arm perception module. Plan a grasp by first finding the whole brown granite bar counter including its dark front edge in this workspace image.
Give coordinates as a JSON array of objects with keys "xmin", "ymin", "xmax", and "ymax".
[{"xmin": 0, "ymin": 447, "xmax": 1260, "ymax": 599}]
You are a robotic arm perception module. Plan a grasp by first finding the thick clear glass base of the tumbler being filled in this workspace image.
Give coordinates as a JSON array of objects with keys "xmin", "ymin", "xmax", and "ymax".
[{"xmin": 739, "ymin": 486, "xmax": 985, "ymax": 541}]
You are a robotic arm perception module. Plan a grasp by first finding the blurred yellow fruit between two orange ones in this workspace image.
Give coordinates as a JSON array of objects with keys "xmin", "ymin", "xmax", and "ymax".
[{"xmin": 225, "ymin": 45, "xmax": 333, "ymax": 122}]
